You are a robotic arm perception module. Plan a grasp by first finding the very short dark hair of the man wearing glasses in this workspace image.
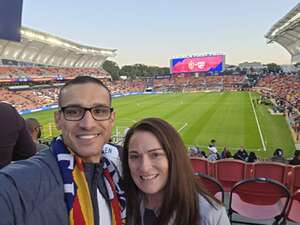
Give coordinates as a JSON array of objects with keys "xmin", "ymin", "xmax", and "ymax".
[{"xmin": 58, "ymin": 76, "xmax": 111, "ymax": 107}]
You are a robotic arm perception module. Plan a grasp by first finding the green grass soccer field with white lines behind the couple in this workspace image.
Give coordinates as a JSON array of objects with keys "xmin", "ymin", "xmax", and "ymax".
[{"xmin": 24, "ymin": 92, "xmax": 295, "ymax": 158}]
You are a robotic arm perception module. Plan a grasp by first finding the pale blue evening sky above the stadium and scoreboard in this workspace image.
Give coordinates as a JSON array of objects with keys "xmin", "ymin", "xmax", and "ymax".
[{"xmin": 22, "ymin": 0, "xmax": 299, "ymax": 67}]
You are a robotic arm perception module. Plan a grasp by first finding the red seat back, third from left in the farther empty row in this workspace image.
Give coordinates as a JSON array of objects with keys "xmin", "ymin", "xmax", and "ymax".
[{"xmin": 252, "ymin": 162, "xmax": 287, "ymax": 184}]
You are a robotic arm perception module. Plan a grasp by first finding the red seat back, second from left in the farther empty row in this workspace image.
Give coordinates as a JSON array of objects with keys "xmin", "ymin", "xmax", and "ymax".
[{"xmin": 214, "ymin": 159, "xmax": 246, "ymax": 192}]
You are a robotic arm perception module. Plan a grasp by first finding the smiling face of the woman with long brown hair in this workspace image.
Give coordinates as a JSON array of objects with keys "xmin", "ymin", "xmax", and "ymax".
[{"xmin": 128, "ymin": 131, "xmax": 169, "ymax": 198}]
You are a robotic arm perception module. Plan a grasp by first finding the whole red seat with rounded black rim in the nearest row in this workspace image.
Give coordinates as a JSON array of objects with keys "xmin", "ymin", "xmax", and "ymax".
[{"xmin": 228, "ymin": 177, "xmax": 290, "ymax": 224}]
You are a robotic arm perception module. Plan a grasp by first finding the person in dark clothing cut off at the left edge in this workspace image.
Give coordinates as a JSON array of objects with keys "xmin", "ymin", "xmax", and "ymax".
[{"xmin": 0, "ymin": 102, "xmax": 36, "ymax": 168}]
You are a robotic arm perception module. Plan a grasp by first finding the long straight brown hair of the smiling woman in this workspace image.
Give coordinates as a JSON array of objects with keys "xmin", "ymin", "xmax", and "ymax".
[{"xmin": 123, "ymin": 118, "xmax": 220, "ymax": 225}]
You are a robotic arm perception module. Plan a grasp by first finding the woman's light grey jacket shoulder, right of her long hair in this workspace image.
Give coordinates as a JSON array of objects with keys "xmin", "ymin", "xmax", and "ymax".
[{"xmin": 198, "ymin": 194, "xmax": 230, "ymax": 225}]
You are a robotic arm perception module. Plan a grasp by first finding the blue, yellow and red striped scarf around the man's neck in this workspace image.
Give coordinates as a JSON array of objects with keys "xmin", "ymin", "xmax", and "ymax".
[{"xmin": 51, "ymin": 136, "xmax": 126, "ymax": 225}]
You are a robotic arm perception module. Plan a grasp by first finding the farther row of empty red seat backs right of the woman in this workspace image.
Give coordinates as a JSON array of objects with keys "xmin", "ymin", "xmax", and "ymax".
[{"xmin": 191, "ymin": 157, "xmax": 300, "ymax": 193}]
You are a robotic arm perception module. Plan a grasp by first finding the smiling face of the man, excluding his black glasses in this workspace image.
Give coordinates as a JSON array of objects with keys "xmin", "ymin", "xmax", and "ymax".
[{"xmin": 55, "ymin": 83, "xmax": 115, "ymax": 163}]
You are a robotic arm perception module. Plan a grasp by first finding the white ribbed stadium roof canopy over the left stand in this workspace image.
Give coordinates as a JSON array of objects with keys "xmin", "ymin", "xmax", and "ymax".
[{"xmin": 0, "ymin": 27, "xmax": 117, "ymax": 68}]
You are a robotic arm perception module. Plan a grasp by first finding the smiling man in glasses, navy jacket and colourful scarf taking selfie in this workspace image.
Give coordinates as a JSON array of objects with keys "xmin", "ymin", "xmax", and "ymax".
[{"xmin": 0, "ymin": 76, "xmax": 126, "ymax": 225}]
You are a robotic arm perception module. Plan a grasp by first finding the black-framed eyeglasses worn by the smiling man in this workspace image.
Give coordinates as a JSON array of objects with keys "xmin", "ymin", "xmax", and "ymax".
[{"xmin": 60, "ymin": 105, "xmax": 114, "ymax": 121}]
